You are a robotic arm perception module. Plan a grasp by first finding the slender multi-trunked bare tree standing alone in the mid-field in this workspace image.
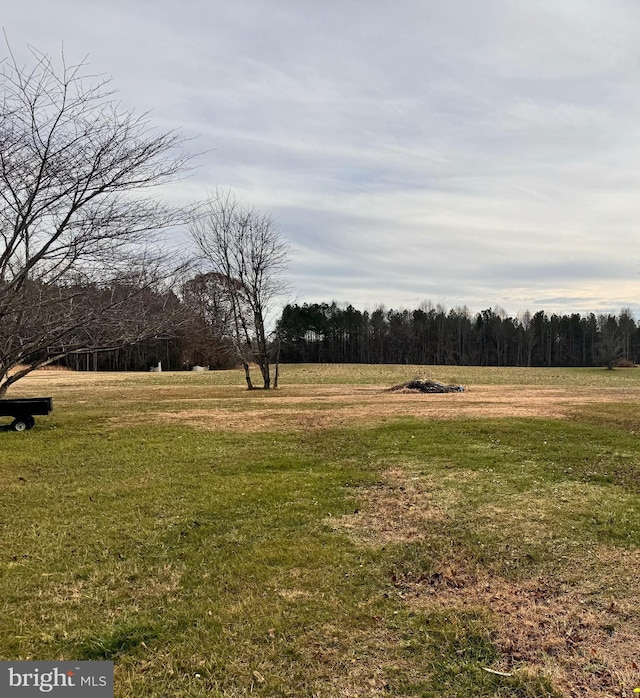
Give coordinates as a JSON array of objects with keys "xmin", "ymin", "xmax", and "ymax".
[{"xmin": 189, "ymin": 191, "xmax": 288, "ymax": 390}]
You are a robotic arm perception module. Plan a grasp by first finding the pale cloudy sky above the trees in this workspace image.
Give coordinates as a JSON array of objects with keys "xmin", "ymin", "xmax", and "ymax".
[{"xmin": 0, "ymin": 0, "xmax": 640, "ymax": 318}]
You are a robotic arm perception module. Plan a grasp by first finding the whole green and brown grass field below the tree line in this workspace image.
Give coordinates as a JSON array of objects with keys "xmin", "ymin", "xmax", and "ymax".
[{"xmin": 0, "ymin": 365, "xmax": 640, "ymax": 698}]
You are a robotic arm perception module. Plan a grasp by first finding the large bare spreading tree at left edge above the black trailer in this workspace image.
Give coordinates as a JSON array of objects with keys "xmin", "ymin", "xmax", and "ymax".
[{"xmin": 0, "ymin": 44, "xmax": 188, "ymax": 396}]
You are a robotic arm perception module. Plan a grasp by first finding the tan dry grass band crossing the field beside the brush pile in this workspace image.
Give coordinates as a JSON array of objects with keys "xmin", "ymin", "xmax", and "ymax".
[{"xmin": 15, "ymin": 367, "xmax": 640, "ymax": 431}]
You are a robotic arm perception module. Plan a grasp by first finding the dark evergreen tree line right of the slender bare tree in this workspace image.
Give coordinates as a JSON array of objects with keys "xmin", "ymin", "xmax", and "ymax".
[{"xmin": 278, "ymin": 302, "xmax": 640, "ymax": 368}]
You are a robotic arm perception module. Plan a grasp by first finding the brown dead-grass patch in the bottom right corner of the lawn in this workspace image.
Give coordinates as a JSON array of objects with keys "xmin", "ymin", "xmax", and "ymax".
[{"xmin": 396, "ymin": 561, "xmax": 640, "ymax": 697}]
